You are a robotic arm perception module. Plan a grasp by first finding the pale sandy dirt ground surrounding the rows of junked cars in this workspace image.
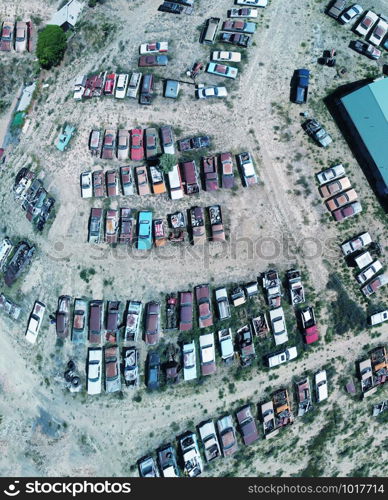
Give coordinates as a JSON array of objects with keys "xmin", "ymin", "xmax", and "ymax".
[{"xmin": 0, "ymin": 0, "xmax": 388, "ymax": 476}]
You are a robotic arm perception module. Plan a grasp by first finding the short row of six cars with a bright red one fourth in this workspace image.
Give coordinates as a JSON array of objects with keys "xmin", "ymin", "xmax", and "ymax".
[{"xmin": 89, "ymin": 125, "xmax": 175, "ymax": 161}]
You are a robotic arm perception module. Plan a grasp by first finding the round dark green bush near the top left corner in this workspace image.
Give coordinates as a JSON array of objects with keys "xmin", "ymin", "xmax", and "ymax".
[{"xmin": 36, "ymin": 24, "xmax": 67, "ymax": 69}]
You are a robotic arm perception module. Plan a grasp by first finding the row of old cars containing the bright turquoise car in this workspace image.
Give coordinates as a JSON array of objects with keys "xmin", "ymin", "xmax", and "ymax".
[{"xmin": 88, "ymin": 205, "xmax": 225, "ymax": 250}]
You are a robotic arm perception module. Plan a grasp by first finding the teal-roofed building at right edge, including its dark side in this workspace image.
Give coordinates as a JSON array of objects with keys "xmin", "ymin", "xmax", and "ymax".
[{"xmin": 339, "ymin": 78, "xmax": 388, "ymax": 206}]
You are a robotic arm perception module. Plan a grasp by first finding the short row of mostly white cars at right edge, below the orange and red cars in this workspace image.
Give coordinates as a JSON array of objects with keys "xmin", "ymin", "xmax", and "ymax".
[{"xmin": 341, "ymin": 232, "xmax": 388, "ymax": 297}]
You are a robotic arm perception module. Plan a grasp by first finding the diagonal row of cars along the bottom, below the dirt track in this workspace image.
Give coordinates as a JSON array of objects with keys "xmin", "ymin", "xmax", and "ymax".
[{"xmin": 138, "ymin": 376, "xmax": 328, "ymax": 477}]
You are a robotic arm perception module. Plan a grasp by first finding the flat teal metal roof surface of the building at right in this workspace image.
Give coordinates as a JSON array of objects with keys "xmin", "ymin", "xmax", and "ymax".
[{"xmin": 341, "ymin": 78, "xmax": 388, "ymax": 186}]
